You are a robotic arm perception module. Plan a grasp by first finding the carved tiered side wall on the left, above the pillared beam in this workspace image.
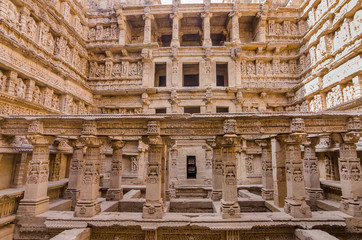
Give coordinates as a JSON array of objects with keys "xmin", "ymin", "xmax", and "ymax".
[{"xmin": 0, "ymin": 0, "xmax": 93, "ymax": 114}]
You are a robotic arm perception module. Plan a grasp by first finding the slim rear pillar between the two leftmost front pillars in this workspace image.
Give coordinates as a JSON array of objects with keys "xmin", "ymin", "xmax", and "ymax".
[{"xmin": 65, "ymin": 139, "xmax": 84, "ymax": 210}]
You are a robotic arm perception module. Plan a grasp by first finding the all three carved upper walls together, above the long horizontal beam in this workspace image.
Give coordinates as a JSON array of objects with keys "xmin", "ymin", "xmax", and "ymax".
[{"xmin": 0, "ymin": 0, "xmax": 361, "ymax": 114}]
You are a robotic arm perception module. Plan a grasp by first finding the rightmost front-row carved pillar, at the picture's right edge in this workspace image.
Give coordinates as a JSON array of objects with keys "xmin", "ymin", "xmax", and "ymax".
[{"xmin": 334, "ymin": 132, "xmax": 362, "ymax": 217}]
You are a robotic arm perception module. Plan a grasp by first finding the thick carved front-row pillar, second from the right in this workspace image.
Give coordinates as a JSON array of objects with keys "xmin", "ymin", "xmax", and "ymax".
[{"xmin": 280, "ymin": 133, "xmax": 312, "ymax": 218}]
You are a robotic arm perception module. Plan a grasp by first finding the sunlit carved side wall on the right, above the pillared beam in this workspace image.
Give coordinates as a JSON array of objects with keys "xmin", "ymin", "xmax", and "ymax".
[{"xmin": 295, "ymin": 0, "xmax": 362, "ymax": 112}]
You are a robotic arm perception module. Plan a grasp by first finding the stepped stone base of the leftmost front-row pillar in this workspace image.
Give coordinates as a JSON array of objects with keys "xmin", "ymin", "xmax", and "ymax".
[{"xmin": 17, "ymin": 197, "xmax": 49, "ymax": 217}]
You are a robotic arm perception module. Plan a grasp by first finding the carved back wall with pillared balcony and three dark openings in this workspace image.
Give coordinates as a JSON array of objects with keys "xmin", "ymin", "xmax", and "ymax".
[{"xmin": 88, "ymin": 1, "xmax": 308, "ymax": 112}]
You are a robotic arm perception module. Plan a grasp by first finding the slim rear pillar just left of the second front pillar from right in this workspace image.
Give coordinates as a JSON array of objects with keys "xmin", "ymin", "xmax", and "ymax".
[{"xmin": 256, "ymin": 140, "xmax": 274, "ymax": 200}]
